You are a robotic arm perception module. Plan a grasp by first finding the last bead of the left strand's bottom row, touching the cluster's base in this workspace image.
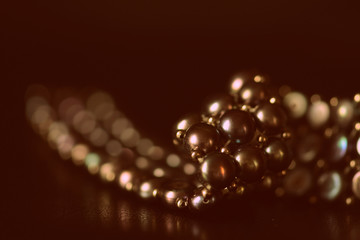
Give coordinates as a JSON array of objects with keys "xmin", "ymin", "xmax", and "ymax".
[{"xmin": 157, "ymin": 179, "xmax": 194, "ymax": 207}]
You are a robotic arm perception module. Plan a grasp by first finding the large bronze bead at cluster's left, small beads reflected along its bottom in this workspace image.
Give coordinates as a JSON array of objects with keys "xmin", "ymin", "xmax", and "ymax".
[{"xmin": 184, "ymin": 123, "xmax": 220, "ymax": 154}]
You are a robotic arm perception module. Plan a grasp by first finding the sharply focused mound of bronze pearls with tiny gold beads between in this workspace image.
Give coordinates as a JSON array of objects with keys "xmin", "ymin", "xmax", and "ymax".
[{"xmin": 174, "ymin": 71, "xmax": 292, "ymax": 208}]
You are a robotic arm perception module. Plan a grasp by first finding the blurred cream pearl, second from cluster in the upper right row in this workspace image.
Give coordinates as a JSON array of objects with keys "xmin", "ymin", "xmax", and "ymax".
[{"xmin": 307, "ymin": 101, "xmax": 330, "ymax": 128}]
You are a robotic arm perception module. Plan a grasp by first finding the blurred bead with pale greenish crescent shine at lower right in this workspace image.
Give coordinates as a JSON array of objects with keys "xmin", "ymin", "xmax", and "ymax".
[{"xmin": 317, "ymin": 171, "xmax": 342, "ymax": 201}]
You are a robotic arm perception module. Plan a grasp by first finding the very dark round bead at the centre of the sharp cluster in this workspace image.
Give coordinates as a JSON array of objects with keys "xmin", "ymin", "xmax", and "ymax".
[{"xmin": 219, "ymin": 110, "xmax": 256, "ymax": 143}]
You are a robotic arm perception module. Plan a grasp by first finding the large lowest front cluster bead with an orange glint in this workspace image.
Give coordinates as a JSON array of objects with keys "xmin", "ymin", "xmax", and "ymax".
[{"xmin": 200, "ymin": 152, "xmax": 237, "ymax": 189}]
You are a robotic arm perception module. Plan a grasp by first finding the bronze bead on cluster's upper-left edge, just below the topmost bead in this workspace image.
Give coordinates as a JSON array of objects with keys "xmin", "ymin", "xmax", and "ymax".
[{"xmin": 205, "ymin": 94, "xmax": 234, "ymax": 116}]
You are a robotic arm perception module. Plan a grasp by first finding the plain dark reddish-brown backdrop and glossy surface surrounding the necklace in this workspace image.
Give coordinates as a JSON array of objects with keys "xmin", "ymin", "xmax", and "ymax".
[{"xmin": 0, "ymin": 0, "xmax": 360, "ymax": 239}]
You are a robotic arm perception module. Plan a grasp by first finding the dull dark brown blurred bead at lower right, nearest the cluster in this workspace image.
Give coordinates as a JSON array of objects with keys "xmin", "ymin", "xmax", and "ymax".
[{"xmin": 284, "ymin": 168, "xmax": 312, "ymax": 196}]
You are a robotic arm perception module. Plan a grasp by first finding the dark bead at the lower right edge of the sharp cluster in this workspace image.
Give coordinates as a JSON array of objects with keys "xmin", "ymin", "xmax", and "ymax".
[{"xmin": 265, "ymin": 139, "xmax": 291, "ymax": 171}]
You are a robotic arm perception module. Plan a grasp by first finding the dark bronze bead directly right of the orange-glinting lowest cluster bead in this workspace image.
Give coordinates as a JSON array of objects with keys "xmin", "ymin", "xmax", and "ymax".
[{"xmin": 234, "ymin": 147, "xmax": 266, "ymax": 182}]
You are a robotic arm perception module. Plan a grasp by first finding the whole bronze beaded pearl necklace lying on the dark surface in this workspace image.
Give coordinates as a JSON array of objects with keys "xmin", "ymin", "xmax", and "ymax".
[{"xmin": 26, "ymin": 73, "xmax": 360, "ymax": 210}]
